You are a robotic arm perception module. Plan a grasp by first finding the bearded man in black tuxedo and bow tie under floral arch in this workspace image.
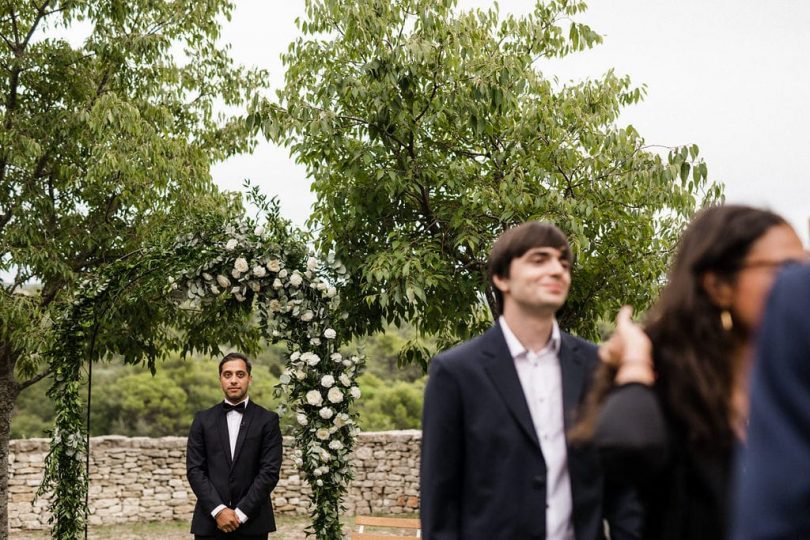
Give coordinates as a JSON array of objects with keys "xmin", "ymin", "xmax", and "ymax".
[{"xmin": 186, "ymin": 353, "xmax": 281, "ymax": 540}]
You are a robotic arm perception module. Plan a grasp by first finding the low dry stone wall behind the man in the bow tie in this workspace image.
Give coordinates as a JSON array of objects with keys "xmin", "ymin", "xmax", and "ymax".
[{"xmin": 8, "ymin": 430, "xmax": 422, "ymax": 532}]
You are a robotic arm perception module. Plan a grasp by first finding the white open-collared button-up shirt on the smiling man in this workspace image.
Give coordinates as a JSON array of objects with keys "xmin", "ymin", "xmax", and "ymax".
[{"xmin": 498, "ymin": 317, "xmax": 574, "ymax": 540}]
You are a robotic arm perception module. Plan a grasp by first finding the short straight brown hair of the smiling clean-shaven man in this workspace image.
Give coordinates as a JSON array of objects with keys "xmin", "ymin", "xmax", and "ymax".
[{"xmin": 487, "ymin": 221, "xmax": 573, "ymax": 313}]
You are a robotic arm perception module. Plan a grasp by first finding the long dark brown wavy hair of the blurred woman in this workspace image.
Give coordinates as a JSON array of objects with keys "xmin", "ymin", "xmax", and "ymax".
[{"xmin": 571, "ymin": 205, "xmax": 786, "ymax": 450}]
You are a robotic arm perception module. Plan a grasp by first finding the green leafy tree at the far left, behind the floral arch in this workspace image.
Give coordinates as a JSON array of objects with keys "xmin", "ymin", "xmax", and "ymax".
[{"xmin": 0, "ymin": 0, "xmax": 264, "ymax": 530}]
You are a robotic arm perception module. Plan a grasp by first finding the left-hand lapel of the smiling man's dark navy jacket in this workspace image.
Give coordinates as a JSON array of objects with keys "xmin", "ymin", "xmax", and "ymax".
[{"xmin": 482, "ymin": 323, "xmax": 540, "ymax": 450}]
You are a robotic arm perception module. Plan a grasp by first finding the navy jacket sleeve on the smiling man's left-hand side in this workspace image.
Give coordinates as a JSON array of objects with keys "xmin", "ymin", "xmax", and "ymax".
[{"xmin": 419, "ymin": 358, "xmax": 464, "ymax": 540}]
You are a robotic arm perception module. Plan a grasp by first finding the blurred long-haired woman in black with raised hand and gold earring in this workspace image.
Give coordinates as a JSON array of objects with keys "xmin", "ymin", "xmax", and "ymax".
[{"xmin": 571, "ymin": 205, "xmax": 805, "ymax": 540}]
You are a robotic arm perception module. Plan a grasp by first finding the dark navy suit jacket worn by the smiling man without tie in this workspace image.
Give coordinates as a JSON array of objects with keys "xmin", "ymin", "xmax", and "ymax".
[{"xmin": 420, "ymin": 324, "xmax": 641, "ymax": 540}]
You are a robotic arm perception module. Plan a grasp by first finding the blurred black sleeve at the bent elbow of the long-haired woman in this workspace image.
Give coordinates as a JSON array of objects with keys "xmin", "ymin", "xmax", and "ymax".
[{"xmin": 594, "ymin": 383, "xmax": 669, "ymax": 482}]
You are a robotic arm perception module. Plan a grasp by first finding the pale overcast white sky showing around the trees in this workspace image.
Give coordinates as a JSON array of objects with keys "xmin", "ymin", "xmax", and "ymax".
[{"xmin": 214, "ymin": 0, "xmax": 810, "ymax": 243}]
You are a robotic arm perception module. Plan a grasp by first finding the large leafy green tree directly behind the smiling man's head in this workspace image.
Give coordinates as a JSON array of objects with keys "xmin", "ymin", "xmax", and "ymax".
[{"xmin": 256, "ymin": 0, "xmax": 722, "ymax": 368}]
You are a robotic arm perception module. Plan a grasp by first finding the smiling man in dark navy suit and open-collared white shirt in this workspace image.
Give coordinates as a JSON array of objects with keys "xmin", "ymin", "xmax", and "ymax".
[{"xmin": 420, "ymin": 221, "xmax": 641, "ymax": 540}]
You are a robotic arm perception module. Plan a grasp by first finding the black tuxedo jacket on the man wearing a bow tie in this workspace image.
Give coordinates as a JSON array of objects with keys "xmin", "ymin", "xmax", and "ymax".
[{"xmin": 186, "ymin": 400, "xmax": 281, "ymax": 535}]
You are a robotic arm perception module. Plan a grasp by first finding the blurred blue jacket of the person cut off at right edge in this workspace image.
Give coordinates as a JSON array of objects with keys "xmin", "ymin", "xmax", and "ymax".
[{"xmin": 734, "ymin": 266, "xmax": 810, "ymax": 540}]
